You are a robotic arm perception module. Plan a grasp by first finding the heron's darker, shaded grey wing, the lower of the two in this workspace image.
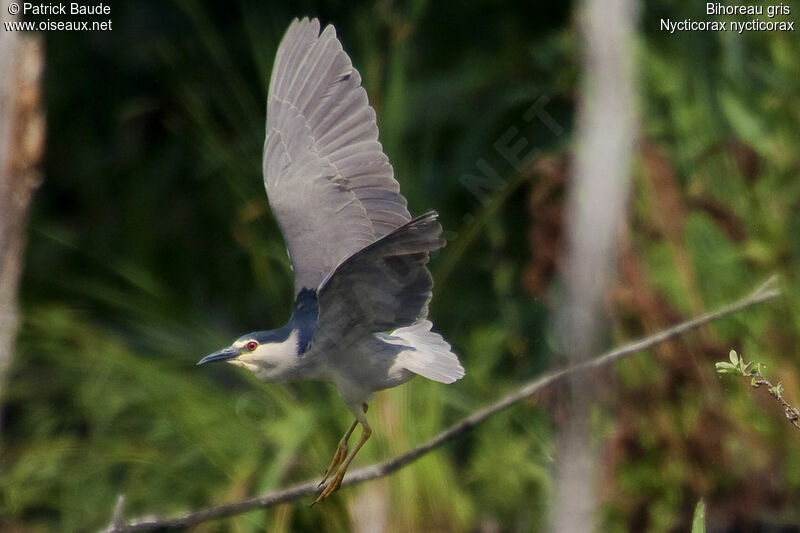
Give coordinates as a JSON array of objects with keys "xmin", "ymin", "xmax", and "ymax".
[{"xmin": 314, "ymin": 211, "xmax": 444, "ymax": 350}]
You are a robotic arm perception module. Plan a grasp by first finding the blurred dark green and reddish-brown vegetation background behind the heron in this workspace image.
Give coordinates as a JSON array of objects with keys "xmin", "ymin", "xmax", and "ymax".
[{"xmin": 0, "ymin": 0, "xmax": 800, "ymax": 532}]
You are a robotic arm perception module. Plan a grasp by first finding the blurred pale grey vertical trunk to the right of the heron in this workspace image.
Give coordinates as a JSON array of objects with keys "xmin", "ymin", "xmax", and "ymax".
[{"xmin": 550, "ymin": 0, "xmax": 636, "ymax": 533}]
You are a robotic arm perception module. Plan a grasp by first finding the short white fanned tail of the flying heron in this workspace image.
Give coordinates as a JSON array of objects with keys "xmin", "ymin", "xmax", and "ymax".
[{"xmin": 385, "ymin": 320, "xmax": 464, "ymax": 383}]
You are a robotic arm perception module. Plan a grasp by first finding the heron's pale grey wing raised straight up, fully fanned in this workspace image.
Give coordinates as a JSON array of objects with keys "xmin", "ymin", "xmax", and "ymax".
[{"xmin": 264, "ymin": 18, "xmax": 411, "ymax": 296}]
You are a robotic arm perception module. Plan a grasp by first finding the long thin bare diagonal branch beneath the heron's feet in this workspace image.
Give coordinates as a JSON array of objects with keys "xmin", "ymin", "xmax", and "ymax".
[{"xmin": 106, "ymin": 276, "xmax": 781, "ymax": 533}]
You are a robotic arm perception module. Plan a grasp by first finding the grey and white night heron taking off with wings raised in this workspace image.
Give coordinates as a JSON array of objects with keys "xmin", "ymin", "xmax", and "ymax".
[{"xmin": 198, "ymin": 19, "xmax": 464, "ymax": 503}]
